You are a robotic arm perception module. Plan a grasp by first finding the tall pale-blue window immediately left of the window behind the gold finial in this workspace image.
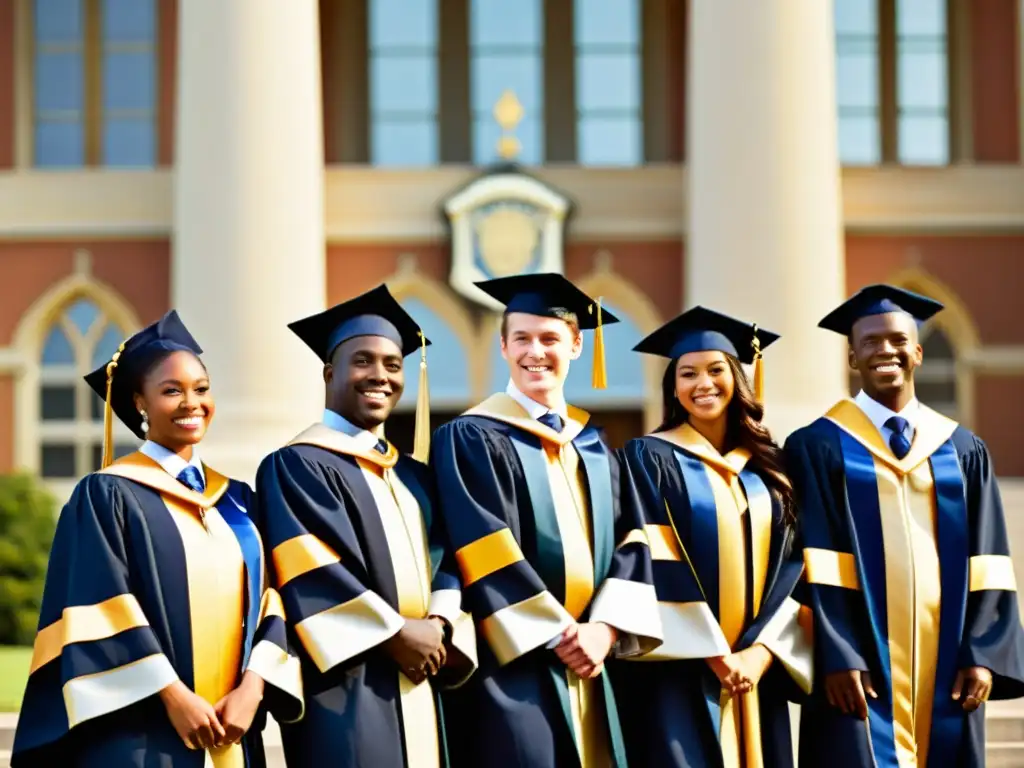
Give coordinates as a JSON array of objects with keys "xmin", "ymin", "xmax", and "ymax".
[{"xmin": 369, "ymin": 0, "xmax": 439, "ymax": 166}]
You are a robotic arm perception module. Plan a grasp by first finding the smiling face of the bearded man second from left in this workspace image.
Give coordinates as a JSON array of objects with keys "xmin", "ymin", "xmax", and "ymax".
[{"xmin": 324, "ymin": 336, "xmax": 406, "ymax": 431}]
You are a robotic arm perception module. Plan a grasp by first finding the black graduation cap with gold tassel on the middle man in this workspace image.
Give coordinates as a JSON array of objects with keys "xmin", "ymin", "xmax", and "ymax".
[{"xmin": 474, "ymin": 272, "xmax": 618, "ymax": 389}]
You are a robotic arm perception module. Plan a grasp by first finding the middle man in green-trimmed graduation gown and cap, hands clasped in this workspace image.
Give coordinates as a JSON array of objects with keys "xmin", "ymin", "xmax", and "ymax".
[{"xmin": 431, "ymin": 274, "xmax": 662, "ymax": 768}]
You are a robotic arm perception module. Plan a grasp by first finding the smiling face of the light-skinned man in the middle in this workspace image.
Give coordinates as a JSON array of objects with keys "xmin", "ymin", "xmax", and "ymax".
[{"xmin": 502, "ymin": 312, "xmax": 583, "ymax": 408}]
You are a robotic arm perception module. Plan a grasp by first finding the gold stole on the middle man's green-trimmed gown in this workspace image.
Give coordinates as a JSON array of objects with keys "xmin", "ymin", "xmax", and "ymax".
[{"xmin": 467, "ymin": 392, "xmax": 611, "ymax": 768}]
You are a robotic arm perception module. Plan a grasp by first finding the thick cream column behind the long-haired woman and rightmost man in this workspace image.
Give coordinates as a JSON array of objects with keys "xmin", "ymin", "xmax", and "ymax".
[{"xmin": 686, "ymin": 0, "xmax": 847, "ymax": 439}]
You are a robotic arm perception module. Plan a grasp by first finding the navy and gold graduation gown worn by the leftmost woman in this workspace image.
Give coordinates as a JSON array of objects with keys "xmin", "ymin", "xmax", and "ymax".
[{"xmin": 11, "ymin": 453, "xmax": 302, "ymax": 768}]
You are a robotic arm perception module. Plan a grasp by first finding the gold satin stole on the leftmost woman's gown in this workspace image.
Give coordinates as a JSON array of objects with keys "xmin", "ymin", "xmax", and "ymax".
[{"xmin": 100, "ymin": 453, "xmax": 246, "ymax": 768}]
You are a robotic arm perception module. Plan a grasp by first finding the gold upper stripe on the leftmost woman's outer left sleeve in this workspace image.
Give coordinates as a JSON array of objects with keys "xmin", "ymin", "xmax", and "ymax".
[{"xmin": 30, "ymin": 593, "xmax": 148, "ymax": 674}]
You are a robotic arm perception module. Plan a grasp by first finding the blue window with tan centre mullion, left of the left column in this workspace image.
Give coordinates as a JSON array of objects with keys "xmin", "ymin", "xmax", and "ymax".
[{"xmin": 32, "ymin": 0, "xmax": 157, "ymax": 168}]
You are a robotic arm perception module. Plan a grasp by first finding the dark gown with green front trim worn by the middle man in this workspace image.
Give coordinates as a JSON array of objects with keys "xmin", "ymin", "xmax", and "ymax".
[{"xmin": 431, "ymin": 393, "xmax": 660, "ymax": 768}]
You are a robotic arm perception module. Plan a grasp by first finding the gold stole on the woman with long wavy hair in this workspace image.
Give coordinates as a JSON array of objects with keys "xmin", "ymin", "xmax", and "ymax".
[{"xmin": 654, "ymin": 424, "xmax": 772, "ymax": 768}]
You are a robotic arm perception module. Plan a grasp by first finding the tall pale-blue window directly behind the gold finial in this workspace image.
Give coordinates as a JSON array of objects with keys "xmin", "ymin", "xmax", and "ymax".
[{"xmin": 469, "ymin": 0, "xmax": 544, "ymax": 165}]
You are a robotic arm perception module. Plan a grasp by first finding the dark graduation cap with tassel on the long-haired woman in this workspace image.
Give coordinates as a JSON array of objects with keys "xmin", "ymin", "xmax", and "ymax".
[{"xmin": 633, "ymin": 306, "xmax": 779, "ymax": 400}]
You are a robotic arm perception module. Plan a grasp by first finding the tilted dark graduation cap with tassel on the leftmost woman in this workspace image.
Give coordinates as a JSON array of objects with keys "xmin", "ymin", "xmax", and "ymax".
[{"xmin": 85, "ymin": 309, "xmax": 203, "ymax": 467}]
